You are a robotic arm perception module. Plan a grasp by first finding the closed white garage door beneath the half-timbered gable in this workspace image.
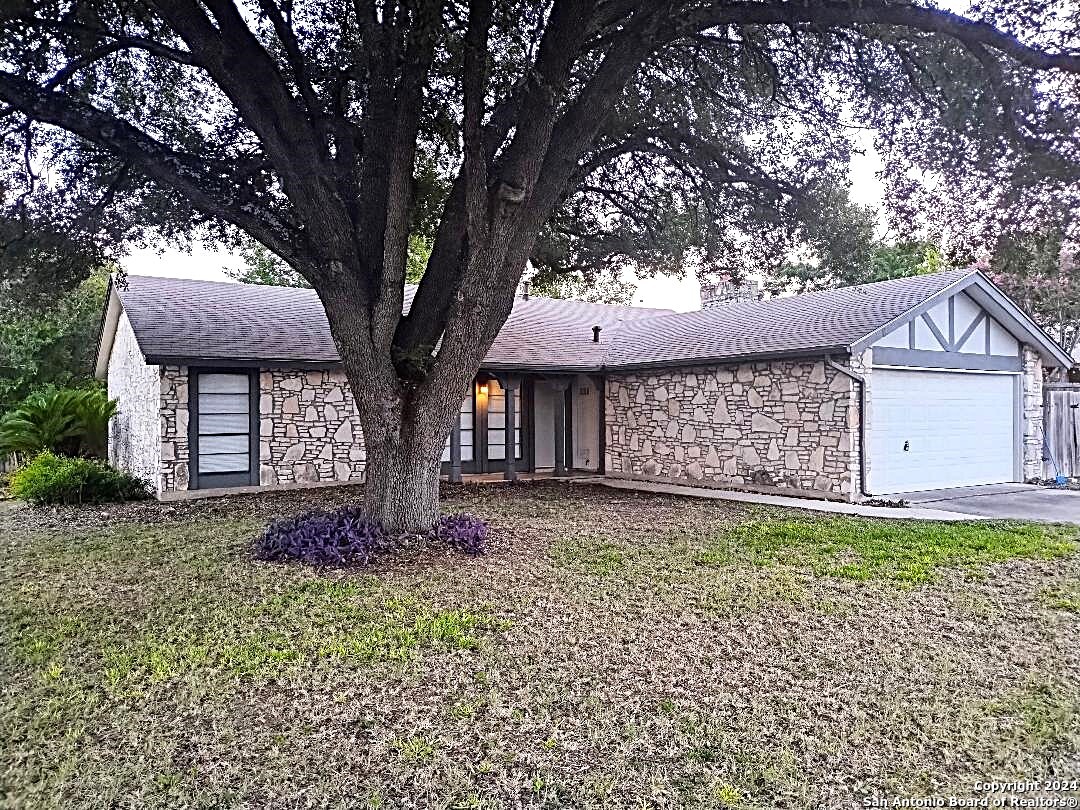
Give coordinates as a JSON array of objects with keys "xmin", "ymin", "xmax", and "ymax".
[{"xmin": 868, "ymin": 368, "xmax": 1016, "ymax": 494}]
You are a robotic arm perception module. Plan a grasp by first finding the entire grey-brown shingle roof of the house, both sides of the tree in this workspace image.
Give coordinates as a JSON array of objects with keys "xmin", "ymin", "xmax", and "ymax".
[{"xmin": 119, "ymin": 270, "xmax": 972, "ymax": 370}]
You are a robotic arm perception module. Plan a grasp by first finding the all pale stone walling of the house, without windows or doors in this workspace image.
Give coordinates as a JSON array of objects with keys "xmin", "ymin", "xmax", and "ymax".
[{"xmin": 118, "ymin": 343, "xmax": 1043, "ymax": 499}]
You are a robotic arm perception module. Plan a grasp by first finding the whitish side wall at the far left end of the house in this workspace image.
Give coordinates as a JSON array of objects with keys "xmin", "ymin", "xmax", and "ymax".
[{"xmin": 106, "ymin": 312, "xmax": 161, "ymax": 488}]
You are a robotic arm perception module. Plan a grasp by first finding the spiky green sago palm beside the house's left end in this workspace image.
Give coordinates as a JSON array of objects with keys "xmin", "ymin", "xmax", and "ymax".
[{"xmin": 0, "ymin": 388, "xmax": 117, "ymax": 458}]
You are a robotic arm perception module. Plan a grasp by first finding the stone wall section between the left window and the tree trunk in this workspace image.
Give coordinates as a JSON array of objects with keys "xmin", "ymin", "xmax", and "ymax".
[{"xmin": 259, "ymin": 368, "xmax": 365, "ymax": 486}]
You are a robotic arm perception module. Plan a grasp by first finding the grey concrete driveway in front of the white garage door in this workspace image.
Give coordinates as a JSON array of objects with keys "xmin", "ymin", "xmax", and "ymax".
[{"xmin": 887, "ymin": 484, "xmax": 1080, "ymax": 525}]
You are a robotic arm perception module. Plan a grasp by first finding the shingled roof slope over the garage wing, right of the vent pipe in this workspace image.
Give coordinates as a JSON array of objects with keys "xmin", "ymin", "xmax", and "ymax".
[{"xmin": 606, "ymin": 270, "xmax": 975, "ymax": 366}]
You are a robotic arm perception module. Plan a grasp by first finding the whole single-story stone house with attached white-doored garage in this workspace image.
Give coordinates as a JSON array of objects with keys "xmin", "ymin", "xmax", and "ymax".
[{"xmin": 96, "ymin": 270, "xmax": 1071, "ymax": 500}]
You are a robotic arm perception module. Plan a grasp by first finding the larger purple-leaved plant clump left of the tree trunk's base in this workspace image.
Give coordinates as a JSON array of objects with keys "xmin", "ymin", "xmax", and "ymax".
[{"xmin": 255, "ymin": 507, "xmax": 393, "ymax": 565}]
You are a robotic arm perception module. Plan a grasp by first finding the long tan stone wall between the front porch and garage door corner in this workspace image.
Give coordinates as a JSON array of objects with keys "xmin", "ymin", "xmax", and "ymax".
[{"xmin": 605, "ymin": 360, "xmax": 860, "ymax": 498}]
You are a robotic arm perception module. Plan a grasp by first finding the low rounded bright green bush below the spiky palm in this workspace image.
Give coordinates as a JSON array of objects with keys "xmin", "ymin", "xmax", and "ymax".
[{"xmin": 10, "ymin": 450, "xmax": 151, "ymax": 503}]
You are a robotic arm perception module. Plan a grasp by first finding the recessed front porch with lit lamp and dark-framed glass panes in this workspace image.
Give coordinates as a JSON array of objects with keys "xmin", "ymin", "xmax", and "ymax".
[{"xmin": 443, "ymin": 372, "xmax": 604, "ymax": 482}]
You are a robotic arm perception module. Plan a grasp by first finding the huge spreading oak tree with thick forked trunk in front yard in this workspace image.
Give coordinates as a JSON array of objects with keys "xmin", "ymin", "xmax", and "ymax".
[{"xmin": 0, "ymin": 0, "xmax": 1080, "ymax": 530}]
